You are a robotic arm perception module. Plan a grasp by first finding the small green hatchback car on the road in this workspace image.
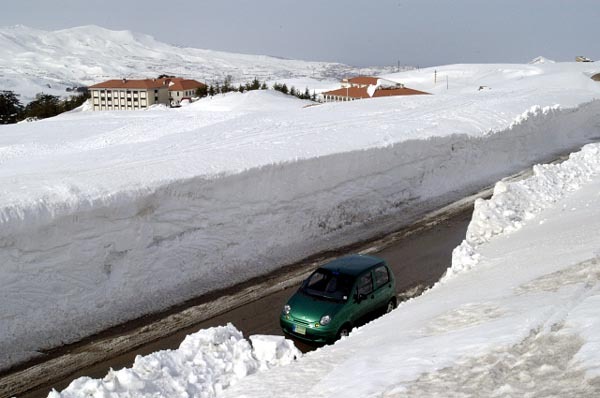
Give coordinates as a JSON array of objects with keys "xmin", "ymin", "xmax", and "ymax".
[{"xmin": 279, "ymin": 255, "xmax": 396, "ymax": 343}]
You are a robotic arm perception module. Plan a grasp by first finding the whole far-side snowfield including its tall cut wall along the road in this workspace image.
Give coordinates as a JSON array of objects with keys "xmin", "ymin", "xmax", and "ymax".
[{"xmin": 0, "ymin": 59, "xmax": 600, "ymax": 374}]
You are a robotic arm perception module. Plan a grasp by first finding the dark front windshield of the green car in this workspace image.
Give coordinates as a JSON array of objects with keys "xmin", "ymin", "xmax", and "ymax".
[{"xmin": 300, "ymin": 269, "xmax": 354, "ymax": 301}]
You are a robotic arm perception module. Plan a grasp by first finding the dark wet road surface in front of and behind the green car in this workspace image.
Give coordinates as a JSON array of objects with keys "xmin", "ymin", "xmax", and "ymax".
[{"xmin": 10, "ymin": 205, "xmax": 472, "ymax": 398}]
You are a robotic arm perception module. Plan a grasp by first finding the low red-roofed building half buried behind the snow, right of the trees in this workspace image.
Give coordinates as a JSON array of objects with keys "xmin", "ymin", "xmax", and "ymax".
[{"xmin": 321, "ymin": 76, "xmax": 429, "ymax": 102}]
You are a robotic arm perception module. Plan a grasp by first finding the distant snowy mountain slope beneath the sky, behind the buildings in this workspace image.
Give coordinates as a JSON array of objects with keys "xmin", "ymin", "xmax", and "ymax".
[{"xmin": 0, "ymin": 25, "xmax": 389, "ymax": 101}]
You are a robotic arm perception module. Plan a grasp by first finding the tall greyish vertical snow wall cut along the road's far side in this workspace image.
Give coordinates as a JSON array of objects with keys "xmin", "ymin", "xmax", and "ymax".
[{"xmin": 0, "ymin": 101, "xmax": 600, "ymax": 368}]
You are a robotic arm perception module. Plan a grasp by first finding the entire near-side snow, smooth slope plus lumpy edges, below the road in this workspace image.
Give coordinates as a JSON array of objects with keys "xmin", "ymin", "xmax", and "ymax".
[{"xmin": 49, "ymin": 130, "xmax": 600, "ymax": 398}]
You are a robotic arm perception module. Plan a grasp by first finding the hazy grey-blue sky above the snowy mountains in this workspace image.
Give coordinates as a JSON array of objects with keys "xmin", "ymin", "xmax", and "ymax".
[{"xmin": 0, "ymin": 0, "xmax": 600, "ymax": 66}]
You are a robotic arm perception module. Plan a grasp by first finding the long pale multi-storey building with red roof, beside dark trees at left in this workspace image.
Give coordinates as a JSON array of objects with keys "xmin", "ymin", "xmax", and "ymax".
[{"xmin": 89, "ymin": 77, "xmax": 205, "ymax": 111}]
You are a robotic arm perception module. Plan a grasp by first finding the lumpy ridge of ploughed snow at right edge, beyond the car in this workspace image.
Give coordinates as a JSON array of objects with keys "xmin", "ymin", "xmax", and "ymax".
[{"xmin": 445, "ymin": 144, "xmax": 600, "ymax": 278}]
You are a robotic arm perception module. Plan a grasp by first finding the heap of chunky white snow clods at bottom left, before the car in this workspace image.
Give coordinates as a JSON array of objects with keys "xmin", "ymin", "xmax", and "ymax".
[{"xmin": 48, "ymin": 324, "xmax": 302, "ymax": 398}]
